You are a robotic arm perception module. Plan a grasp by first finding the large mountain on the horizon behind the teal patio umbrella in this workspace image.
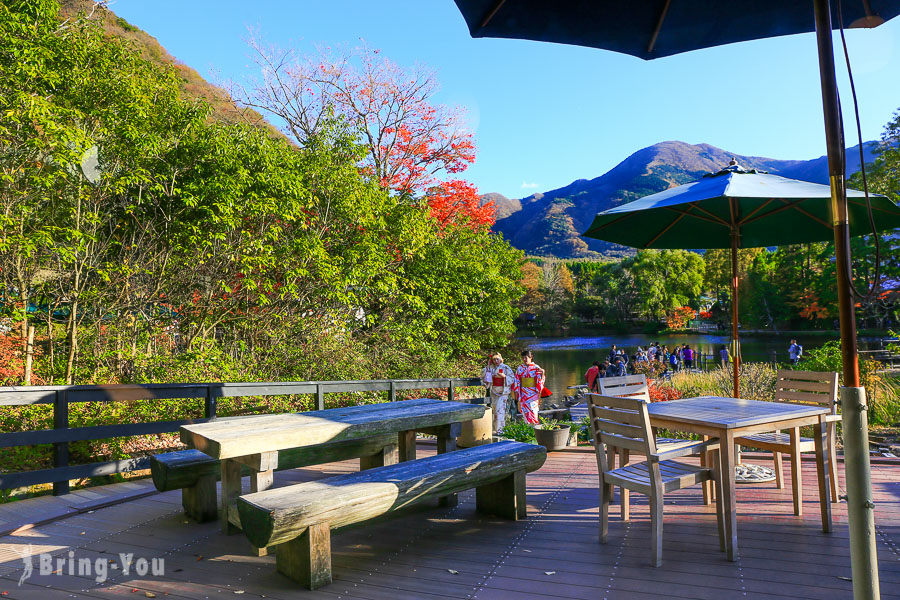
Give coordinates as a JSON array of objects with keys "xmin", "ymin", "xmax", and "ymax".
[{"xmin": 486, "ymin": 141, "xmax": 874, "ymax": 258}]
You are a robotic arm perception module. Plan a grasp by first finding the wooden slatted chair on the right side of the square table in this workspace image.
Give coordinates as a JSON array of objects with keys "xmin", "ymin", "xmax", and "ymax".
[{"xmin": 734, "ymin": 369, "xmax": 841, "ymax": 516}]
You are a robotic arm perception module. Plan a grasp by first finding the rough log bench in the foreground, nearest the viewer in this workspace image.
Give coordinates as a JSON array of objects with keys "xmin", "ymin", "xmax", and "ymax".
[{"xmin": 237, "ymin": 441, "xmax": 547, "ymax": 590}]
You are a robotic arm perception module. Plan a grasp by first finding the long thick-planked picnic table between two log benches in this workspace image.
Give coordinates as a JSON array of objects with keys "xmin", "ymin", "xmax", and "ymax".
[{"xmin": 181, "ymin": 398, "xmax": 484, "ymax": 533}]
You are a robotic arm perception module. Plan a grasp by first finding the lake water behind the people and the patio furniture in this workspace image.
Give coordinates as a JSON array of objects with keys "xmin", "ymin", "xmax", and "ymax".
[{"xmin": 520, "ymin": 333, "xmax": 881, "ymax": 402}]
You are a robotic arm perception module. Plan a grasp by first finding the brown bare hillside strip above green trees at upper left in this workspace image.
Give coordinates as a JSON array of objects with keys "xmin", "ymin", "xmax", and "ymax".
[{"xmin": 60, "ymin": 0, "xmax": 283, "ymax": 137}]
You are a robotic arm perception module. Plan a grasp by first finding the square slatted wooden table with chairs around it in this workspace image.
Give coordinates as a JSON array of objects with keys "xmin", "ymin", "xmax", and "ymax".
[{"xmin": 647, "ymin": 396, "xmax": 832, "ymax": 561}]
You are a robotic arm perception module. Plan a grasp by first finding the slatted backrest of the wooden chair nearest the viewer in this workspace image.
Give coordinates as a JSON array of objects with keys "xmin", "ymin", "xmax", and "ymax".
[{"xmin": 587, "ymin": 394, "xmax": 656, "ymax": 473}]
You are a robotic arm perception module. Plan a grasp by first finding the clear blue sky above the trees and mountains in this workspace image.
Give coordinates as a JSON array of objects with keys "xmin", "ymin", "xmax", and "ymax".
[{"xmin": 110, "ymin": 0, "xmax": 900, "ymax": 198}]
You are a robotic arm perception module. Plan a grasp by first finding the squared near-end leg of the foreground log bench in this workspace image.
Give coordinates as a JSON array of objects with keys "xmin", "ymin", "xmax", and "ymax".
[{"xmin": 275, "ymin": 523, "xmax": 331, "ymax": 590}]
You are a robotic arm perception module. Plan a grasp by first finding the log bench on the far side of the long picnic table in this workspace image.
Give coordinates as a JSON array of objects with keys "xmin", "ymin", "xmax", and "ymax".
[{"xmin": 150, "ymin": 434, "xmax": 397, "ymax": 523}]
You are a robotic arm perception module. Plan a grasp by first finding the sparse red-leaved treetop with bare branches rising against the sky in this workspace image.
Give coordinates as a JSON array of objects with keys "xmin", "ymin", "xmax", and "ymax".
[{"xmin": 230, "ymin": 40, "xmax": 493, "ymax": 225}]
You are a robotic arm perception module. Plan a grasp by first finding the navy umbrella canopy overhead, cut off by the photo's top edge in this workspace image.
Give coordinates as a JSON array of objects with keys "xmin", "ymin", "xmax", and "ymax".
[{"xmin": 455, "ymin": 0, "xmax": 900, "ymax": 60}]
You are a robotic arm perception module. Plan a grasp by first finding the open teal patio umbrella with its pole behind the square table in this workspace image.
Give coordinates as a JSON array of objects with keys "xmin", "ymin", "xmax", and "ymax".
[{"xmin": 583, "ymin": 161, "xmax": 900, "ymax": 398}]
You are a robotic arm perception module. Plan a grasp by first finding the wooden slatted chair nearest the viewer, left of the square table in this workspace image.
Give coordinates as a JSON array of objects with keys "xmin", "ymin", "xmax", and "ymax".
[{"xmin": 588, "ymin": 394, "xmax": 725, "ymax": 567}]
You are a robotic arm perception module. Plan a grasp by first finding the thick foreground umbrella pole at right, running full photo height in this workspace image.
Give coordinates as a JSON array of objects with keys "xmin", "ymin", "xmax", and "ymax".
[{"xmin": 813, "ymin": 0, "xmax": 881, "ymax": 600}]
